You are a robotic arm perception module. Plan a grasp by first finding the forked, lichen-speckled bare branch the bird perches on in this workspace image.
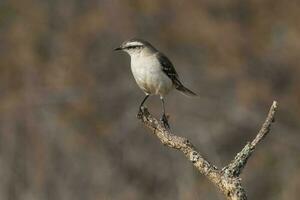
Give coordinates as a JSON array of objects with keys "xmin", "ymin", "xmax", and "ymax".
[{"xmin": 138, "ymin": 101, "xmax": 277, "ymax": 200}]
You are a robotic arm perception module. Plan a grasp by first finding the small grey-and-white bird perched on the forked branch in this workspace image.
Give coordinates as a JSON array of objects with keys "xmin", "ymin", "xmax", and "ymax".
[{"xmin": 114, "ymin": 38, "xmax": 197, "ymax": 129}]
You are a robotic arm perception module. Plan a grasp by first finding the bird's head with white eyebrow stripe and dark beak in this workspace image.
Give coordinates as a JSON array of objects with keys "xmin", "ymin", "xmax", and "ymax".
[{"xmin": 115, "ymin": 39, "xmax": 156, "ymax": 56}]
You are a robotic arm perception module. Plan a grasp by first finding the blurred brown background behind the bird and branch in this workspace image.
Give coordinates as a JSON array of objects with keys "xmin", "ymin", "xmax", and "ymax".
[{"xmin": 0, "ymin": 0, "xmax": 300, "ymax": 200}]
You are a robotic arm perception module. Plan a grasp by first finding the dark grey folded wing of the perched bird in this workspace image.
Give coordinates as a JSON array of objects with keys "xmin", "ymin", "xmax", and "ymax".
[{"xmin": 157, "ymin": 53, "xmax": 182, "ymax": 88}]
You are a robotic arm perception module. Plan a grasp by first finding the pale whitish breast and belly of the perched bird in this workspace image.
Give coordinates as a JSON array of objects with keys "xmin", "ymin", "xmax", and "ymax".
[{"xmin": 131, "ymin": 55, "xmax": 173, "ymax": 96}]
